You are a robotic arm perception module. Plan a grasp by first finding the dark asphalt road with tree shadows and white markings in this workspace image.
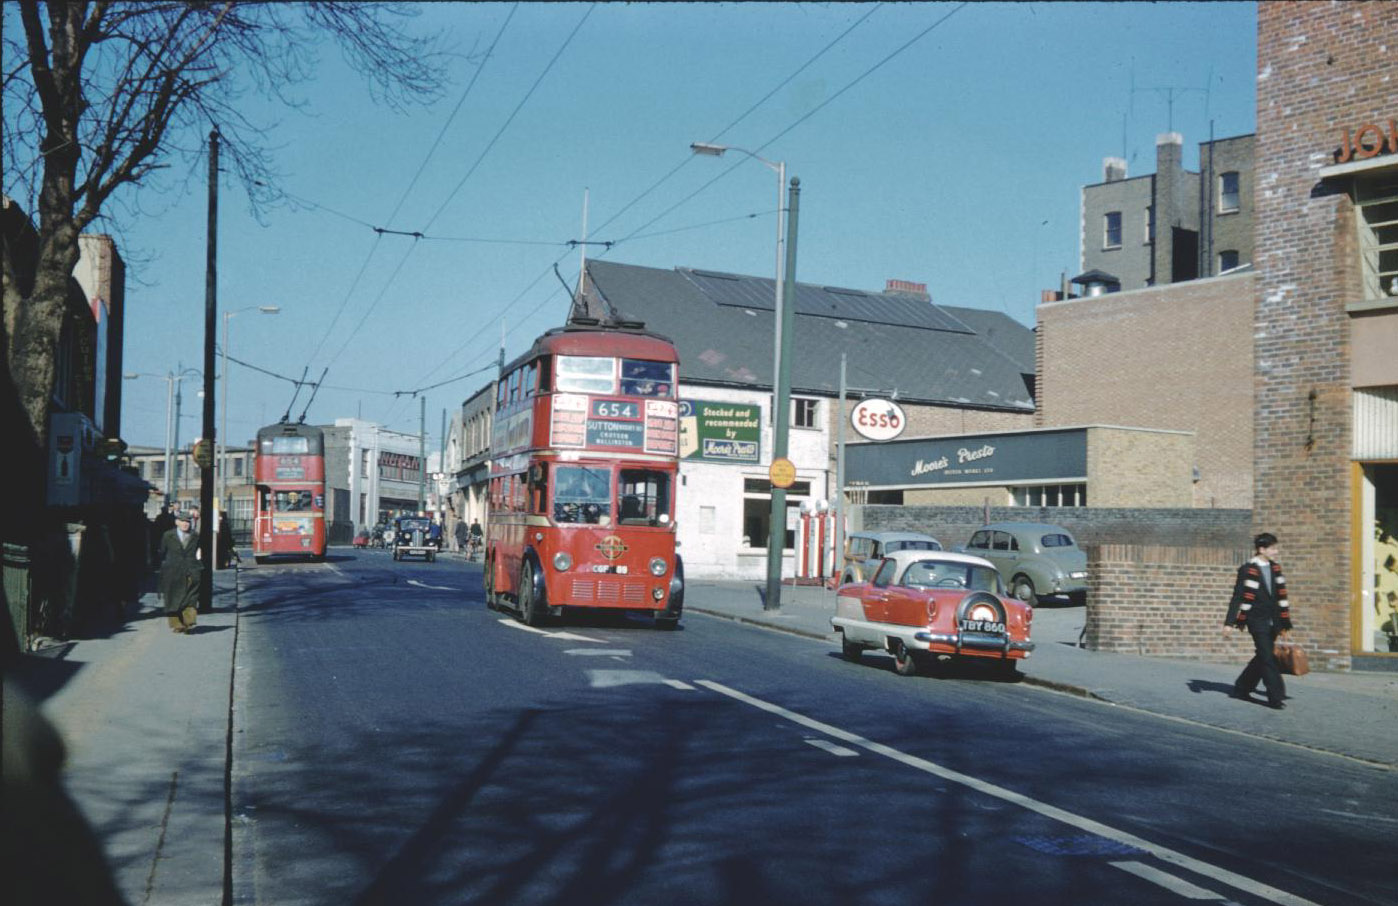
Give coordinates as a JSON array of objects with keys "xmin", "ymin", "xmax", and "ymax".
[{"xmin": 231, "ymin": 551, "xmax": 1398, "ymax": 906}]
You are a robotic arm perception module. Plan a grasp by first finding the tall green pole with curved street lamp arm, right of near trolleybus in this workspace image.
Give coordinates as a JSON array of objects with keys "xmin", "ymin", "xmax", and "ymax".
[{"xmin": 689, "ymin": 141, "xmax": 801, "ymax": 611}]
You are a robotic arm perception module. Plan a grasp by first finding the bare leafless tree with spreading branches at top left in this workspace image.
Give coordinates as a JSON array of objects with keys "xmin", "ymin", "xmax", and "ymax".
[{"xmin": 0, "ymin": 0, "xmax": 443, "ymax": 528}]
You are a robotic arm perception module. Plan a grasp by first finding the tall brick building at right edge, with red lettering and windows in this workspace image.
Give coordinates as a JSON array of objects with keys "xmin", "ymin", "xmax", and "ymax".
[{"xmin": 1253, "ymin": 3, "xmax": 1398, "ymax": 668}]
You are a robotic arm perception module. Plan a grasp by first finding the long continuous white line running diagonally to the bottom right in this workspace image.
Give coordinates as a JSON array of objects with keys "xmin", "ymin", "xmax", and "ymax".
[{"xmin": 696, "ymin": 680, "xmax": 1318, "ymax": 906}]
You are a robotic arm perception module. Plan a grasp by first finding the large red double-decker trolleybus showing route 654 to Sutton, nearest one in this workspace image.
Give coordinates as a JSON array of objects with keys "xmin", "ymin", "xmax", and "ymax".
[{"xmin": 485, "ymin": 320, "xmax": 684, "ymax": 629}]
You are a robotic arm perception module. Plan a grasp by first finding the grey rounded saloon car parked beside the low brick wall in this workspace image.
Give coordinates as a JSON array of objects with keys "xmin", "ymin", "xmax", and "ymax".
[{"xmin": 966, "ymin": 523, "xmax": 1088, "ymax": 604}]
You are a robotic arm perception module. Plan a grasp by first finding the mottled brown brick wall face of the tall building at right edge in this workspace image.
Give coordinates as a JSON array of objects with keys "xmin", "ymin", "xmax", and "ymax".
[{"xmin": 1253, "ymin": 3, "xmax": 1398, "ymax": 661}]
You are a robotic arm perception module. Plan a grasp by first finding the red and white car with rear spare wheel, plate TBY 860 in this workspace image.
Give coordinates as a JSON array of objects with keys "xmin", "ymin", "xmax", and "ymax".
[{"xmin": 830, "ymin": 551, "xmax": 1035, "ymax": 677}]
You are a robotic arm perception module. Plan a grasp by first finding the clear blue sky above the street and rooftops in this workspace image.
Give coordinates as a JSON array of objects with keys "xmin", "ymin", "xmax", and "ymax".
[{"xmin": 101, "ymin": 3, "xmax": 1257, "ymax": 450}]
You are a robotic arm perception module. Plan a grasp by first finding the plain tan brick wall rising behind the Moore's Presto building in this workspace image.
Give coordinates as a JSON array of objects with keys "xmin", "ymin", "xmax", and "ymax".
[{"xmin": 1036, "ymin": 273, "xmax": 1255, "ymax": 509}]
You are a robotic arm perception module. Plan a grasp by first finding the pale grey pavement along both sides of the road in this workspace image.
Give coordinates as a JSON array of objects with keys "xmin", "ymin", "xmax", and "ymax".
[{"xmin": 11, "ymin": 555, "xmax": 1398, "ymax": 906}]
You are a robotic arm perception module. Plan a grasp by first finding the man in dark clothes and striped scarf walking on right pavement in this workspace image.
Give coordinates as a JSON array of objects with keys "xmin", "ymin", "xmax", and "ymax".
[{"xmin": 1225, "ymin": 531, "xmax": 1292, "ymax": 710}]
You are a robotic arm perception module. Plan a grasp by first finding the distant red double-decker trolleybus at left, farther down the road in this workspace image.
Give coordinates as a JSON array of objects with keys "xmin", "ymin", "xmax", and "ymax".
[{"xmin": 253, "ymin": 421, "xmax": 326, "ymax": 563}]
